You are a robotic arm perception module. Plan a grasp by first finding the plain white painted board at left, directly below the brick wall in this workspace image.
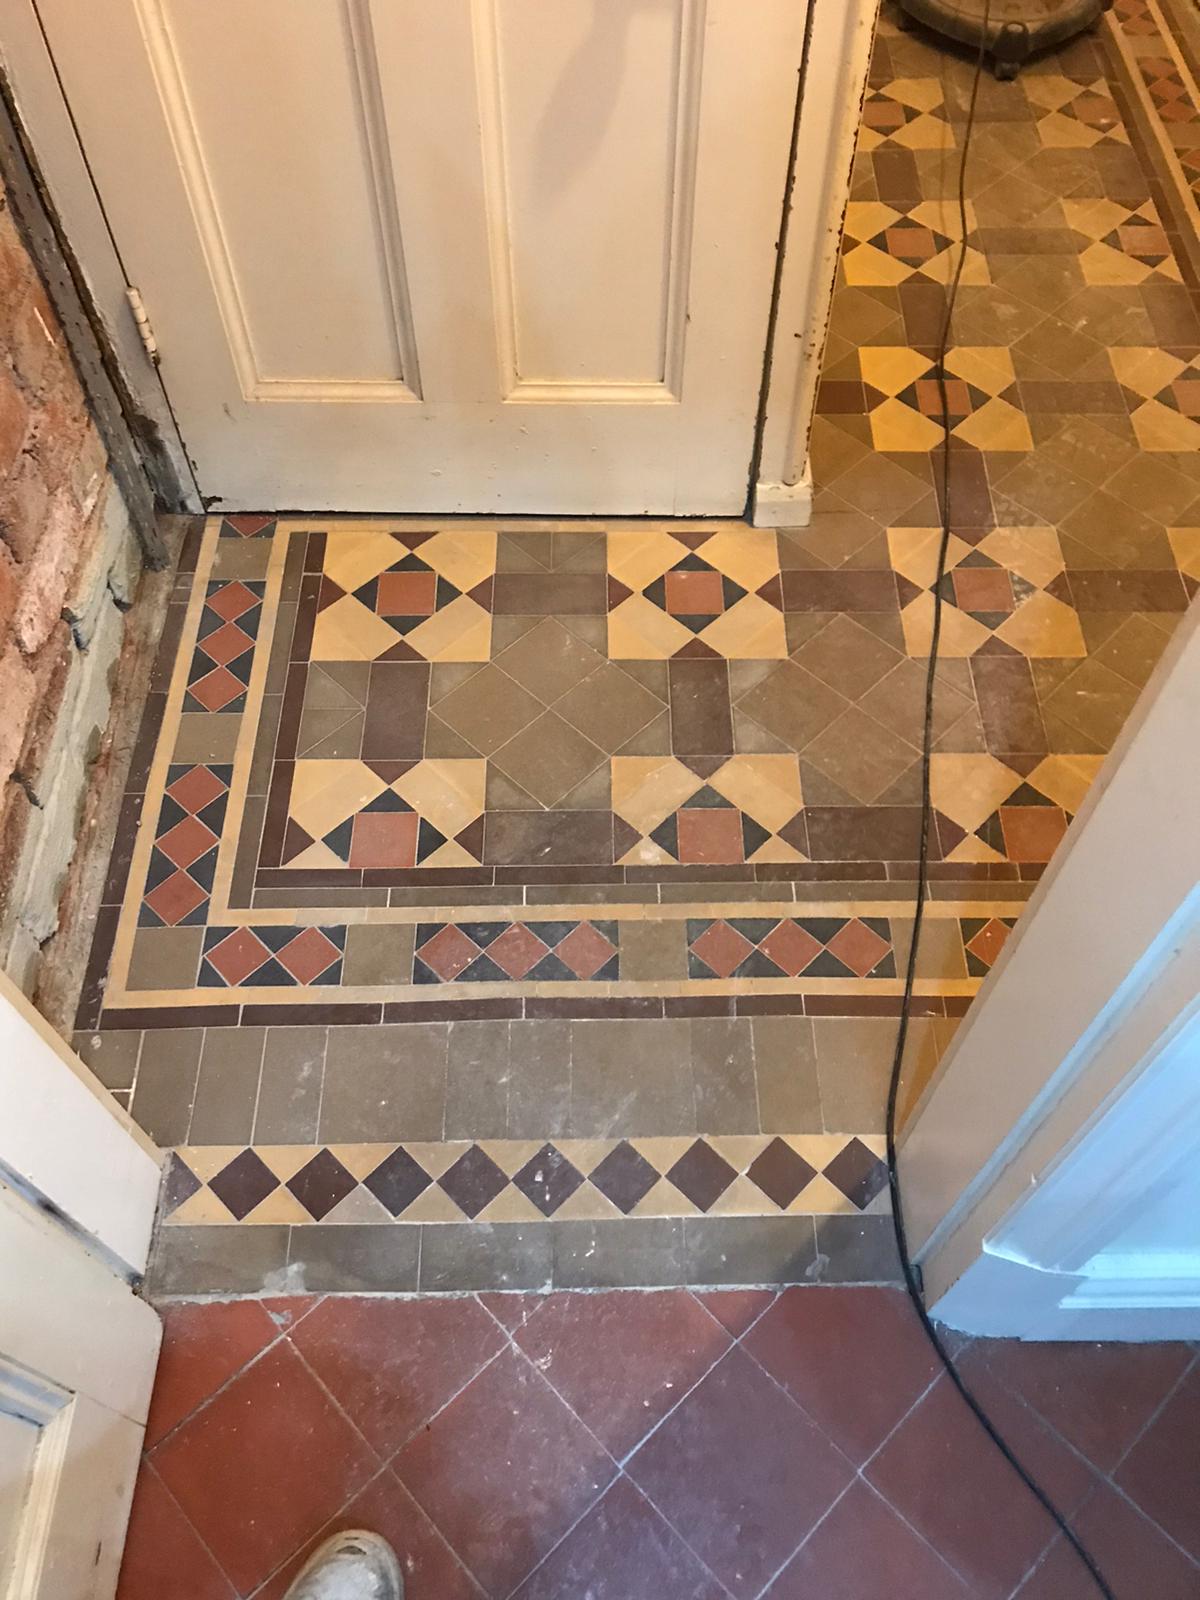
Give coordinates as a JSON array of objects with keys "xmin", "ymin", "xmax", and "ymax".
[{"xmin": 0, "ymin": 973, "xmax": 162, "ymax": 1274}]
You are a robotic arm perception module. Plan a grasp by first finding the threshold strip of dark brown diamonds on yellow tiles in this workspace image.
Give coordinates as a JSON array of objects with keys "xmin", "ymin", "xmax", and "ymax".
[{"xmin": 166, "ymin": 1133, "xmax": 886, "ymax": 1226}]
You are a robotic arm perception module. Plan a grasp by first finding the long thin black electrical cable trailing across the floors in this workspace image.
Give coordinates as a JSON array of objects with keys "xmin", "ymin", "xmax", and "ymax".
[{"xmin": 886, "ymin": 15, "xmax": 1117, "ymax": 1600}]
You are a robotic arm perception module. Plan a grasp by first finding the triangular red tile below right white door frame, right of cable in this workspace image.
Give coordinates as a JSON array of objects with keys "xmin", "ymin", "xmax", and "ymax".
[{"xmin": 976, "ymin": 1339, "xmax": 1192, "ymax": 1472}]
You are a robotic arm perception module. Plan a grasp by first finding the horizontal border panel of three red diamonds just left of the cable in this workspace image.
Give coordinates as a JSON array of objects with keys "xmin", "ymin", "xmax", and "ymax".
[{"xmin": 688, "ymin": 917, "xmax": 896, "ymax": 979}]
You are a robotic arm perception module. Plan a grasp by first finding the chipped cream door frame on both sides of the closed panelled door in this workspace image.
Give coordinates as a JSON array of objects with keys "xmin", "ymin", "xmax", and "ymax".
[{"xmin": 0, "ymin": 0, "xmax": 878, "ymax": 526}]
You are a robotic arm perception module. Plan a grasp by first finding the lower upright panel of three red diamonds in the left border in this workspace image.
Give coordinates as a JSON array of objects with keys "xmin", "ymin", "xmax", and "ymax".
[{"xmin": 138, "ymin": 763, "xmax": 234, "ymax": 928}]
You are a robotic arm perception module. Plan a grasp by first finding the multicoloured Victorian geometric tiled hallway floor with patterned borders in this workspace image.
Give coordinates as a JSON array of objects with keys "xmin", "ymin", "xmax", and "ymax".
[{"xmin": 77, "ymin": 0, "xmax": 1200, "ymax": 1293}]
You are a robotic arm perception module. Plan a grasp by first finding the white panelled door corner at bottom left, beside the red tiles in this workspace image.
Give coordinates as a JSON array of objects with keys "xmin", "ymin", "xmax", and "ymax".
[{"xmin": 0, "ymin": 1184, "xmax": 162, "ymax": 1600}]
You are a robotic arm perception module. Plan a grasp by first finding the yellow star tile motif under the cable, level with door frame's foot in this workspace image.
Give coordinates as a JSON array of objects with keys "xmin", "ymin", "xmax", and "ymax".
[{"xmin": 888, "ymin": 528, "xmax": 1088, "ymax": 658}]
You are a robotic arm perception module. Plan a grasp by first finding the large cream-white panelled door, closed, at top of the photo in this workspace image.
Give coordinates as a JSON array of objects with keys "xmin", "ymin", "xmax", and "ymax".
[{"xmin": 37, "ymin": 0, "xmax": 805, "ymax": 515}]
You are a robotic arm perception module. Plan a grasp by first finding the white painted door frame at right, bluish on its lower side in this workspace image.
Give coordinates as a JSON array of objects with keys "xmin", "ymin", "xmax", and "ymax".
[{"xmin": 899, "ymin": 602, "xmax": 1200, "ymax": 1339}]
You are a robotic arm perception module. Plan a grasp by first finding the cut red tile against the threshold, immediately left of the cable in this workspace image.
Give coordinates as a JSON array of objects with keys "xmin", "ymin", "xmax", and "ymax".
[{"xmin": 742, "ymin": 1286, "xmax": 938, "ymax": 1462}]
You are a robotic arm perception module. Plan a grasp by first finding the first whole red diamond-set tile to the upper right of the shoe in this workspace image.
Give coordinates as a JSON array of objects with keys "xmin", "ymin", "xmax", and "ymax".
[{"xmin": 395, "ymin": 1350, "xmax": 616, "ymax": 1595}]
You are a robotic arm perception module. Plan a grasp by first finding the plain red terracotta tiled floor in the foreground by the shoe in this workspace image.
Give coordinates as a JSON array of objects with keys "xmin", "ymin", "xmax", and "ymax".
[{"xmin": 118, "ymin": 1288, "xmax": 1200, "ymax": 1600}]
